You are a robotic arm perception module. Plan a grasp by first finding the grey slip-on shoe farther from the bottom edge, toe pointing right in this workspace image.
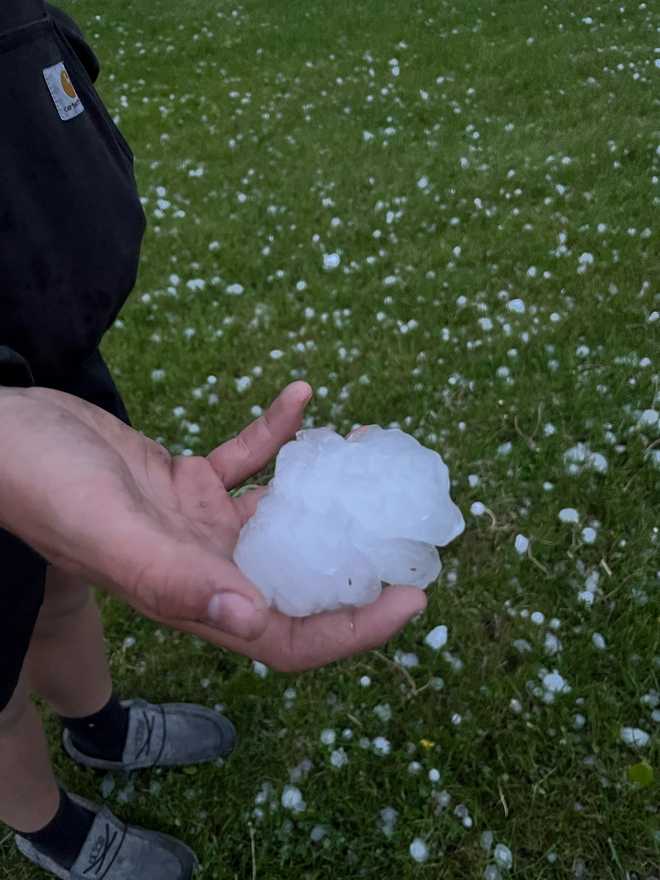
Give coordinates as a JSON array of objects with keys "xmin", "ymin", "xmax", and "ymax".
[{"xmin": 62, "ymin": 700, "xmax": 236, "ymax": 772}]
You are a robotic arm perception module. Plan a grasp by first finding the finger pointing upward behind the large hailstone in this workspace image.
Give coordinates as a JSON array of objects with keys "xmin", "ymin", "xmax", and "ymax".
[{"xmin": 208, "ymin": 382, "xmax": 312, "ymax": 489}]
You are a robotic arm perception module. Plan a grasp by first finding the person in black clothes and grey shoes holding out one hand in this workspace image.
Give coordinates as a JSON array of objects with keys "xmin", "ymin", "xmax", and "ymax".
[{"xmin": 0, "ymin": 0, "xmax": 425, "ymax": 880}]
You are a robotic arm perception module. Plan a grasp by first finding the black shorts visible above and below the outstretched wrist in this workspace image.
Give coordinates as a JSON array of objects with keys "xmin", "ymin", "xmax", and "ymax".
[{"xmin": 0, "ymin": 351, "xmax": 130, "ymax": 711}]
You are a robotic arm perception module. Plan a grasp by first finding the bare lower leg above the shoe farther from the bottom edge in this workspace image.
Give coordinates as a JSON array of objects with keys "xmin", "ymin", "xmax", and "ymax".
[{"xmin": 25, "ymin": 567, "xmax": 112, "ymax": 718}]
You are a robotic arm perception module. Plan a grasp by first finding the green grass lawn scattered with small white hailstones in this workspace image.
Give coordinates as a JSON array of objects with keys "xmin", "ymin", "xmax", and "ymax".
[{"xmin": 0, "ymin": 0, "xmax": 660, "ymax": 880}]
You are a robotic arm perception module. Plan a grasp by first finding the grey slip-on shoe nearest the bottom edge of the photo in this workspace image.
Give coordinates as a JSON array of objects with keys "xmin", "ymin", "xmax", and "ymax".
[{"xmin": 15, "ymin": 795, "xmax": 198, "ymax": 880}]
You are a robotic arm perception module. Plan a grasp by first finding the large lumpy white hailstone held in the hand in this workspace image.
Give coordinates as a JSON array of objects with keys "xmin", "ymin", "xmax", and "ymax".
[{"xmin": 234, "ymin": 427, "xmax": 465, "ymax": 617}]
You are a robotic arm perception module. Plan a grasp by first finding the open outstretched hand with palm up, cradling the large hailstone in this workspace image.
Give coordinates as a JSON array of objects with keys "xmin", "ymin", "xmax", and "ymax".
[{"xmin": 0, "ymin": 382, "xmax": 426, "ymax": 670}]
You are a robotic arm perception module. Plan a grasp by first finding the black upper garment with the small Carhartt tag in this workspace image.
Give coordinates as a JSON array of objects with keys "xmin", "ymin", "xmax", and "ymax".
[{"xmin": 0, "ymin": 0, "xmax": 145, "ymax": 380}]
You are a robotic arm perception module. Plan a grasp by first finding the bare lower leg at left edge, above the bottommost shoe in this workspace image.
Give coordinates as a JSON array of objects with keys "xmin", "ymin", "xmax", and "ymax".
[{"xmin": 0, "ymin": 677, "xmax": 60, "ymax": 834}]
